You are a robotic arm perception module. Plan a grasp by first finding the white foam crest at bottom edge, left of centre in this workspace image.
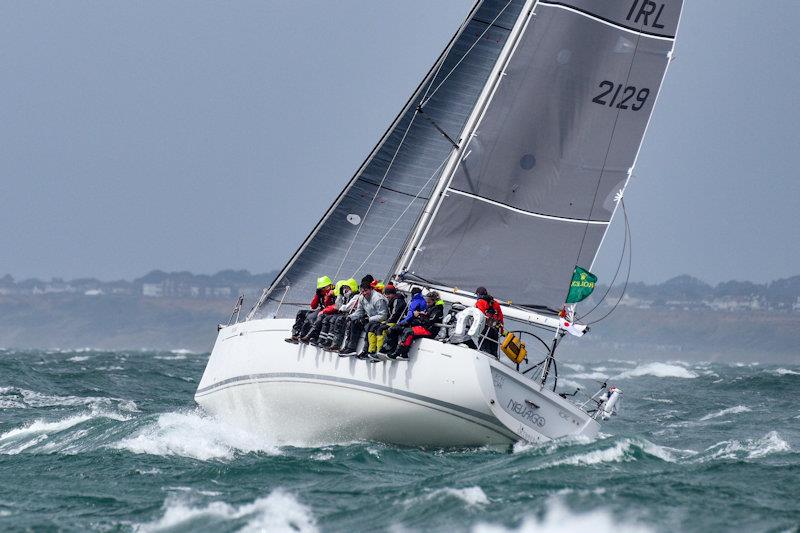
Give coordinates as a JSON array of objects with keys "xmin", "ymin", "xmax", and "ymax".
[{"xmin": 135, "ymin": 489, "xmax": 318, "ymax": 533}]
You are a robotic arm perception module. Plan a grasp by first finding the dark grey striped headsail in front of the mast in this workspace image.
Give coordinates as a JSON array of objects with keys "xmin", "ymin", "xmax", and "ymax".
[{"xmin": 251, "ymin": 0, "xmax": 525, "ymax": 317}]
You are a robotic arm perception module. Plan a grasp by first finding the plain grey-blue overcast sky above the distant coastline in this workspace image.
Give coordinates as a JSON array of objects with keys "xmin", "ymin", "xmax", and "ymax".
[{"xmin": 0, "ymin": 0, "xmax": 800, "ymax": 282}]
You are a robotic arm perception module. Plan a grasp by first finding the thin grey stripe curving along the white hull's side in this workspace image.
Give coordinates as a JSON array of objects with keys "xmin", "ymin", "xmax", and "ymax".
[{"xmin": 195, "ymin": 372, "xmax": 517, "ymax": 438}]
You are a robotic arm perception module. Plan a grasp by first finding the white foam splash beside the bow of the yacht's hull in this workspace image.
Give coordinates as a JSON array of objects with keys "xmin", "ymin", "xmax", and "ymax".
[{"xmin": 112, "ymin": 411, "xmax": 280, "ymax": 461}]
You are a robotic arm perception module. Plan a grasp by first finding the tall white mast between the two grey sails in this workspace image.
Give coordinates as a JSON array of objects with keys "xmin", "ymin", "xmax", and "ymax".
[{"xmin": 393, "ymin": 0, "xmax": 538, "ymax": 275}]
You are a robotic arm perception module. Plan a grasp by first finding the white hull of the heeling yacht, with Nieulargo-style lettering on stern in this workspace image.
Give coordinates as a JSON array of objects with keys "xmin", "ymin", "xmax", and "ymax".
[{"xmin": 195, "ymin": 319, "xmax": 599, "ymax": 447}]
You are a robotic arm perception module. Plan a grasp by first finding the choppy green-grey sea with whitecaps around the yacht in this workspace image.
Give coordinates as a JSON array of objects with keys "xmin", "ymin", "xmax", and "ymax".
[{"xmin": 0, "ymin": 349, "xmax": 800, "ymax": 533}]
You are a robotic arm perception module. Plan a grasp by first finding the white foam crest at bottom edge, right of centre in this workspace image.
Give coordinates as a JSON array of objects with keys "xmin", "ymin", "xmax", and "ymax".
[{"xmin": 472, "ymin": 499, "xmax": 653, "ymax": 533}]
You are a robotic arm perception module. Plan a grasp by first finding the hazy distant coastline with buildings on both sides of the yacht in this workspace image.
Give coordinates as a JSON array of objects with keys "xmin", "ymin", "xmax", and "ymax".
[{"xmin": 0, "ymin": 270, "xmax": 800, "ymax": 361}]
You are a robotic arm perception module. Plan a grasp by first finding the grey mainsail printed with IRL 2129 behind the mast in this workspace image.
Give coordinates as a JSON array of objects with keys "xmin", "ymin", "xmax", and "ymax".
[{"xmin": 400, "ymin": 0, "xmax": 682, "ymax": 309}]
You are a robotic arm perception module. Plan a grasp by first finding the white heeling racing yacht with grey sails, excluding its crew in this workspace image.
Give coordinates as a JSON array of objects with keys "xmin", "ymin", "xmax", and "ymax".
[{"xmin": 195, "ymin": 0, "xmax": 682, "ymax": 447}]
